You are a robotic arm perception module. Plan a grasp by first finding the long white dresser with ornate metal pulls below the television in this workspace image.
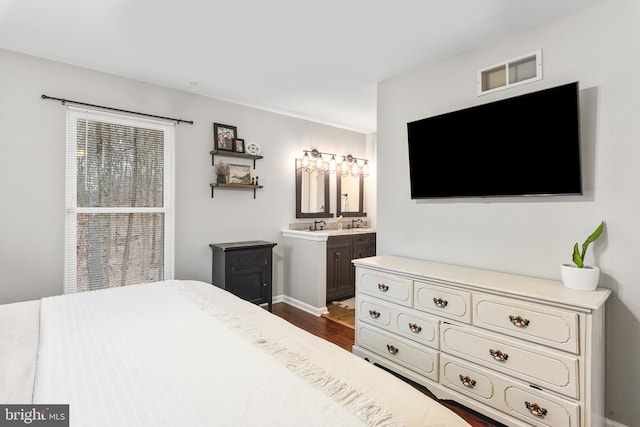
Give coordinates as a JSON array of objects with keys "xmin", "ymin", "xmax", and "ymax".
[{"xmin": 353, "ymin": 256, "xmax": 611, "ymax": 427}]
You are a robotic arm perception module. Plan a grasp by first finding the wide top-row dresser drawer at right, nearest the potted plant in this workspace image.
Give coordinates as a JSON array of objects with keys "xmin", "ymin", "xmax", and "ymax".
[{"xmin": 473, "ymin": 293, "xmax": 579, "ymax": 354}]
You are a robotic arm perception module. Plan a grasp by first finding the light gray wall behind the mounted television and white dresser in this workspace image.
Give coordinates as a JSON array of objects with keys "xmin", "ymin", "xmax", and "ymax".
[{"xmin": 377, "ymin": 0, "xmax": 640, "ymax": 426}]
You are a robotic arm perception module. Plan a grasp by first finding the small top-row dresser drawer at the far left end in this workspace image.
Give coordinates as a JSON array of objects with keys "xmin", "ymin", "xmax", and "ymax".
[{"xmin": 356, "ymin": 269, "xmax": 413, "ymax": 307}]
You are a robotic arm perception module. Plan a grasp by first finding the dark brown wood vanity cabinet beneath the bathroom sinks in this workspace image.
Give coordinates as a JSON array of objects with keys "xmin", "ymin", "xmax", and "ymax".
[{"xmin": 327, "ymin": 233, "xmax": 376, "ymax": 303}]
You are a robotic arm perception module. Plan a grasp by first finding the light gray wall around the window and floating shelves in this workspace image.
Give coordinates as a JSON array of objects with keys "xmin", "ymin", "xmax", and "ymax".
[{"xmin": 0, "ymin": 49, "xmax": 369, "ymax": 303}]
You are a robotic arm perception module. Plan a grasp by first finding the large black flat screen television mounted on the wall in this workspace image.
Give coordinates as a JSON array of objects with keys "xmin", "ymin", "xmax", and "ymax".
[{"xmin": 407, "ymin": 82, "xmax": 582, "ymax": 199}]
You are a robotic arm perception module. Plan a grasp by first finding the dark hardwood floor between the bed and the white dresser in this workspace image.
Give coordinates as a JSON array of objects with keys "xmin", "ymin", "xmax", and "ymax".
[{"xmin": 273, "ymin": 302, "xmax": 506, "ymax": 427}]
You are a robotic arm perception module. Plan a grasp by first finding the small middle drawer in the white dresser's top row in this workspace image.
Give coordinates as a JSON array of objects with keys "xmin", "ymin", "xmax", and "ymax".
[{"xmin": 413, "ymin": 281, "xmax": 471, "ymax": 323}]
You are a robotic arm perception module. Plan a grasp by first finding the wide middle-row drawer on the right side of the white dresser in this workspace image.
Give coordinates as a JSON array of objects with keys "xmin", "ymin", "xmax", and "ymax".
[{"xmin": 440, "ymin": 323, "xmax": 580, "ymax": 399}]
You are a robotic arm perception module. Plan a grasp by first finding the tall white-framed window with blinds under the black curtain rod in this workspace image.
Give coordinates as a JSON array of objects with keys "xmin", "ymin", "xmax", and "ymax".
[{"xmin": 64, "ymin": 107, "xmax": 175, "ymax": 293}]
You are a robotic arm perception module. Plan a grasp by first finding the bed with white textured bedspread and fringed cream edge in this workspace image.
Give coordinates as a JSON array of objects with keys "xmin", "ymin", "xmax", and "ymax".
[{"xmin": 0, "ymin": 280, "xmax": 468, "ymax": 427}]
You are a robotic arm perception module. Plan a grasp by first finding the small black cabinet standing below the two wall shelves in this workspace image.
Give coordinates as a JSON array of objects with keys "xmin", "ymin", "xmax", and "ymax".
[{"xmin": 209, "ymin": 240, "xmax": 276, "ymax": 311}]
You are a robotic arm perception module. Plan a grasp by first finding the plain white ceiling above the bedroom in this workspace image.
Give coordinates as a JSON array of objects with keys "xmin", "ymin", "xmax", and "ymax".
[{"xmin": 0, "ymin": 0, "xmax": 605, "ymax": 132}]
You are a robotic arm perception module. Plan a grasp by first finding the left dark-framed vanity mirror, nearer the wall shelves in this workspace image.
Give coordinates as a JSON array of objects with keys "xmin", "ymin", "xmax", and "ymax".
[{"xmin": 296, "ymin": 159, "xmax": 333, "ymax": 218}]
